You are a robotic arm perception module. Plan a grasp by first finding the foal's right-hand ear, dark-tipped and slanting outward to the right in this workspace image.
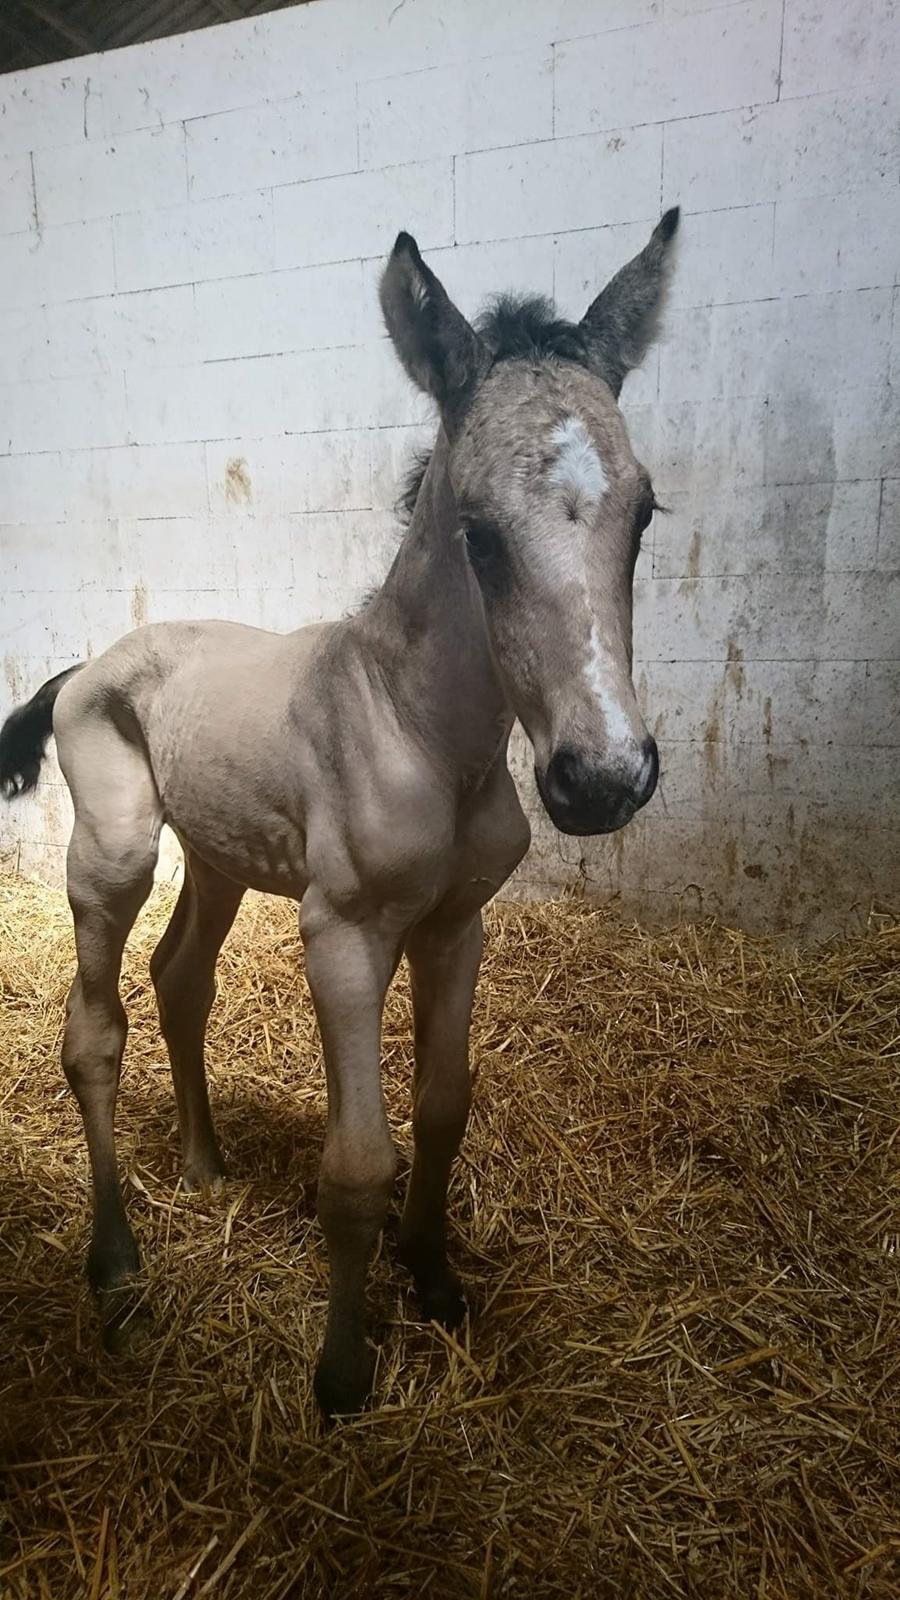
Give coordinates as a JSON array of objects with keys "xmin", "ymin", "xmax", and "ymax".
[{"xmin": 581, "ymin": 206, "xmax": 679, "ymax": 397}]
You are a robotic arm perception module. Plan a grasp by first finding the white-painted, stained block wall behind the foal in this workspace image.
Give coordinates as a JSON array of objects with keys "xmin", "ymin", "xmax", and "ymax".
[{"xmin": 0, "ymin": 0, "xmax": 900, "ymax": 931}]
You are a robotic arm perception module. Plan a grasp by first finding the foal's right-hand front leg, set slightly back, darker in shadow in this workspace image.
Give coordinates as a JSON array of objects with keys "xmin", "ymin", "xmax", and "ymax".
[{"xmin": 400, "ymin": 912, "xmax": 484, "ymax": 1328}]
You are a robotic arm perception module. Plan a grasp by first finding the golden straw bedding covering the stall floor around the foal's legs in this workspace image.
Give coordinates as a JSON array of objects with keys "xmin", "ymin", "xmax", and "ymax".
[{"xmin": 0, "ymin": 878, "xmax": 900, "ymax": 1600}]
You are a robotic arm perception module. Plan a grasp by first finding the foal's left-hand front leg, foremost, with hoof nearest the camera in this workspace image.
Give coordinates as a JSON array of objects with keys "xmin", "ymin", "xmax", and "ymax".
[{"xmin": 301, "ymin": 891, "xmax": 397, "ymax": 1416}]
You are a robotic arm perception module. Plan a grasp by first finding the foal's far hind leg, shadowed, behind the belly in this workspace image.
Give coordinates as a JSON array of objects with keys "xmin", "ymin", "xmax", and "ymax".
[{"xmin": 151, "ymin": 851, "xmax": 243, "ymax": 1189}]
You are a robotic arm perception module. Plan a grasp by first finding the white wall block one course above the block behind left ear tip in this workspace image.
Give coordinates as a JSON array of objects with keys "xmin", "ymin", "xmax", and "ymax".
[{"xmin": 359, "ymin": 50, "xmax": 552, "ymax": 166}]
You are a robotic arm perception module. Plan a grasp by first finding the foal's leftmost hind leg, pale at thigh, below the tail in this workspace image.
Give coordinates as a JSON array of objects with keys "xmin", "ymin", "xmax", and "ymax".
[{"xmin": 61, "ymin": 723, "xmax": 159, "ymax": 1346}]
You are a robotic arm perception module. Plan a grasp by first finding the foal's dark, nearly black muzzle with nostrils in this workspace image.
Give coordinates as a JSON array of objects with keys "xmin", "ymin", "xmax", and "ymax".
[{"xmin": 535, "ymin": 736, "xmax": 660, "ymax": 834}]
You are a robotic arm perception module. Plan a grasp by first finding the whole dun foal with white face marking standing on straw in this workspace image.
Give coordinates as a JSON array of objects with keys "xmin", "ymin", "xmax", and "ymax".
[{"xmin": 0, "ymin": 211, "xmax": 677, "ymax": 1413}]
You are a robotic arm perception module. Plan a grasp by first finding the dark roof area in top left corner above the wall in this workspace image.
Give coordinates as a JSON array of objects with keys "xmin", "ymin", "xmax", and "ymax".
[{"xmin": 0, "ymin": 0, "xmax": 304, "ymax": 72}]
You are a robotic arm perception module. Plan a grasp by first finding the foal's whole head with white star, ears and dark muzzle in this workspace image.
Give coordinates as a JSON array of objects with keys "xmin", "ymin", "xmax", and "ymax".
[{"xmin": 374, "ymin": 210, "xmax": 677, "ymax": 834}]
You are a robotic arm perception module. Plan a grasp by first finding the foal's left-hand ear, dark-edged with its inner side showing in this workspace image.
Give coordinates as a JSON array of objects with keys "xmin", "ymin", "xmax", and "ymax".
[{"xmin": 381, "ymin": 234, "xmax": 490, "ymax": 432}]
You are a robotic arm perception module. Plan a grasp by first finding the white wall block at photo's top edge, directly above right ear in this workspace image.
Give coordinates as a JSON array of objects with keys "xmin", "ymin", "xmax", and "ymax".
[{"xmin": 556, "ymin": 0, "xmax": 781, "ymax": 138}]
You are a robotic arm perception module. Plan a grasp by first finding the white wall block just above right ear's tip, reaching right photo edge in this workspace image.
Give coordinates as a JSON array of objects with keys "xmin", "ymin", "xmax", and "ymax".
[{"xmin": 665, "ymin": 90, "xmax": 900, "ymax": 211}]
